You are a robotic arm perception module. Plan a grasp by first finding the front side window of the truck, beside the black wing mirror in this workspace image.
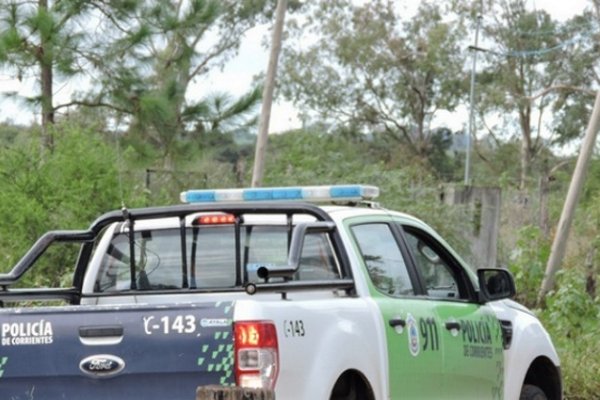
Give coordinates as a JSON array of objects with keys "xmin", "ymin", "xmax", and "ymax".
[{"xmin": 405, "ymin": 230, "xmax": 466, "ymax": 299}]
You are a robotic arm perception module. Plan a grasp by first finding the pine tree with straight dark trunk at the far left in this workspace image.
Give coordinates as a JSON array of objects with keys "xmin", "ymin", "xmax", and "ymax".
[{"xmin": 0, "ymin": 0, "xmax": 87, "ymax": 149}]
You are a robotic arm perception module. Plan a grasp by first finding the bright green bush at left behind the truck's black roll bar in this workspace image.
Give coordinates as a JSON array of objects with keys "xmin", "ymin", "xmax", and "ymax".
[{"xmin": 0, "ymin": 125, "xmax": 142, "ymax": 287}]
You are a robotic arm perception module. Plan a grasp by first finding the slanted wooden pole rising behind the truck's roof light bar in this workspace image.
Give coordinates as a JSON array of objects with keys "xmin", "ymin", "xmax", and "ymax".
[{"xmin": 252, "ymin": 0, "xmax": 287, "ymax": 187}]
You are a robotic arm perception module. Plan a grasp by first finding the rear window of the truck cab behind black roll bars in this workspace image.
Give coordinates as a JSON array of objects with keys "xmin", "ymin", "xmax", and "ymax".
[{"xmin": 95, "ymin": 225, "xmax": 340, "ymax": 292}]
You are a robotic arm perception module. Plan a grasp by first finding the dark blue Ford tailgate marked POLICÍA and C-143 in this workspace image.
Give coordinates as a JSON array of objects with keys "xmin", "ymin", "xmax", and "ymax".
[{"xmin": 0, "ymin": 302, "xmax": 235, "ymax": 400}]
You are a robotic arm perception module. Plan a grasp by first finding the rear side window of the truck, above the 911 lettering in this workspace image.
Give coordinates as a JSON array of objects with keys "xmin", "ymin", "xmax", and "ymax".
[{"xmin": 352, "ymin": 223, "xmax": 414, "ymax": 297}]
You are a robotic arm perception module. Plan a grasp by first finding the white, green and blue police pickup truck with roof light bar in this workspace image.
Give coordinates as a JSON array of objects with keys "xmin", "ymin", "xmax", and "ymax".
[{"xmin": 0, "ymin": 185, "xmax": 561, "ymax": 400}]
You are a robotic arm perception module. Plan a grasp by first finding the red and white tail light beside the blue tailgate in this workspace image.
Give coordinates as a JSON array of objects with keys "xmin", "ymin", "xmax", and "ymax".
[{"xmin": 234, "ymin": 321, "xmax": 279, "ymax": 389}]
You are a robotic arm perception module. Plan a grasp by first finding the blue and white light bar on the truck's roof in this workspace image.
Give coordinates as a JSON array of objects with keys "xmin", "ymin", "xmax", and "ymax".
[{"xmin": 181, "ymin": 185, "xmax": 379, "ymax": 203}]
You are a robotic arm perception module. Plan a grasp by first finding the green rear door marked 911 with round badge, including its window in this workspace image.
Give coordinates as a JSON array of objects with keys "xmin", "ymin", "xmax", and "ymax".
[{"xmin": 350, "ymin": 219, "xmax": 444, "ymax": 399}]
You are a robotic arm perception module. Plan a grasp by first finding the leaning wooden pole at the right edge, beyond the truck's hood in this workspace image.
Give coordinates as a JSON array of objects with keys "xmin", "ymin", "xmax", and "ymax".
[{"xmin": 537, "ymin": 91, "xmax": 600, "ymax": 306}]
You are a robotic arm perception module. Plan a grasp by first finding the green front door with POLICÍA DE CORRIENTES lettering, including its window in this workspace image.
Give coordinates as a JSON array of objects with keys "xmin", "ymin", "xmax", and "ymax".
[{"xmin": 403, "ymin": 226, "xmax": 504, "ymax": 400}]
